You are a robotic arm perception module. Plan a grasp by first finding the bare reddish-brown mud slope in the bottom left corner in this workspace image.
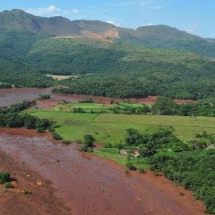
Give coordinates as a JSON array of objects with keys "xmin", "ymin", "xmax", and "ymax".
[{"xmin": 0, "ymin": 151, "xmax": 71, "ymax": 215}]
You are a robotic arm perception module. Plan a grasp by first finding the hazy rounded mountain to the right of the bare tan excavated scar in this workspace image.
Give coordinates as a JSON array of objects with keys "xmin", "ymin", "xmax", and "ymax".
[{"xmin": 119, "ymin": 25, "xmax": 215, "ymax": 58}]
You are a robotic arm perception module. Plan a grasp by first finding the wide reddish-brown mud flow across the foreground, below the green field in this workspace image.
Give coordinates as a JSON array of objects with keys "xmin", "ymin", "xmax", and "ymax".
[{"xmin": 0, "ymin": 129, "xmax": 204, "ymax": 215}]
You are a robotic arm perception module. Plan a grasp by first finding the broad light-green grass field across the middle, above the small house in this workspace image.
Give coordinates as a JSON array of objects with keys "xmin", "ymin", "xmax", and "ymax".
[{"xmin": 28, "ymin": 110, "xmax": 215, "ymax": 144}]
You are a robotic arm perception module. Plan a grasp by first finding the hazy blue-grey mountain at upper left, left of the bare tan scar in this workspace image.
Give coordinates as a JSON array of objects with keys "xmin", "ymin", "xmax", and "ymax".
[{"xmin": 0, "ymin": 9, "xmax": 115, "ymax": 36}]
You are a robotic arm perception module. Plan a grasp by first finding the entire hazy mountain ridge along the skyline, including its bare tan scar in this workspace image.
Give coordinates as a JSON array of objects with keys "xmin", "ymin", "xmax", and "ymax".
[{"xmin": 0, "ymin": 9, "xmax": 215, "ymax": 59}]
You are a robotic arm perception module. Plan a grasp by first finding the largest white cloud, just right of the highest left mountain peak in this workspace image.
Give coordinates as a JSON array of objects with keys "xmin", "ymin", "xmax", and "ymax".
[{"xmin": 25, "ymin": 5, "xmax": 80, "ymax": 16}]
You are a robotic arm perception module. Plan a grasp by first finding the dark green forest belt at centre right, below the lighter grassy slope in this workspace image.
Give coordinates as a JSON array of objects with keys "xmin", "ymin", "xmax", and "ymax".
[{"xmin": 55, "ymin": 54, "xmax": 215, "ymax": 100}]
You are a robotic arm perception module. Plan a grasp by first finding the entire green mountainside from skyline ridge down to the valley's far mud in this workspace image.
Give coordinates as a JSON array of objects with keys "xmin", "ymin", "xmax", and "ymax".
[{"xmin": 0, "ymin": 10, "xmax": 215, "ymax": 99}]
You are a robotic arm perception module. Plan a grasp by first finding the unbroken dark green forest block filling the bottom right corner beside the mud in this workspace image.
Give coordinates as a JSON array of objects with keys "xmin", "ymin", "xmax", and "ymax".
[{"xmin": 150, "ymin": 149, "xmax": 215, "ymax": 214}]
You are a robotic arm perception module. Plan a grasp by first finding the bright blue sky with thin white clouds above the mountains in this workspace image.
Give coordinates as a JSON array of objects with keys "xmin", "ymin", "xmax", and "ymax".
[{"xmin": 0, "ymin": 0, "xmax": 215, "ymax": 38}]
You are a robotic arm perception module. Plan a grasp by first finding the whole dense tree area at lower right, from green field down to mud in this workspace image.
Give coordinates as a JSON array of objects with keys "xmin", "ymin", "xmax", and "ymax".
[{"xmin": 104, "ymin": 128, "xmax": 215, "ymax": 214}]
